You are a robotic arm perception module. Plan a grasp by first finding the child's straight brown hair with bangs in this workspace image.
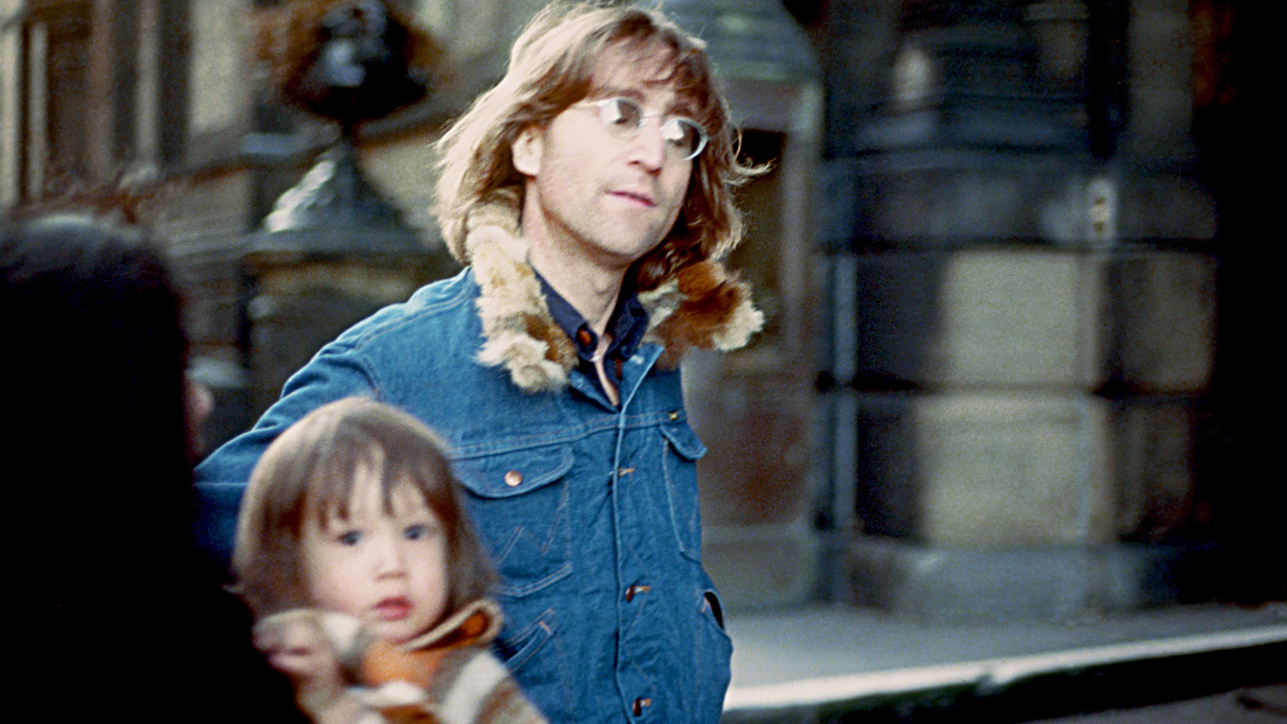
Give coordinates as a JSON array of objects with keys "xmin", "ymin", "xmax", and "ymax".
[{"xmin": 233, "ymin": 397, "xmax": 494, "ymax": 617}]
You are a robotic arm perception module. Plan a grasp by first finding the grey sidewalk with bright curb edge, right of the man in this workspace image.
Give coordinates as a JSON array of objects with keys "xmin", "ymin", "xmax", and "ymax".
[{"xmin": 723, "ymin": 603, "xmax": 1287, "ymax": 724}]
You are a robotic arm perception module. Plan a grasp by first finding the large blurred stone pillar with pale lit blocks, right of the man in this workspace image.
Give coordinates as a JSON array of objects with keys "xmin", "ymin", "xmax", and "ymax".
[{"xmin": 820, "ymin": 0, "xmax": 1215, "ymax": 617}]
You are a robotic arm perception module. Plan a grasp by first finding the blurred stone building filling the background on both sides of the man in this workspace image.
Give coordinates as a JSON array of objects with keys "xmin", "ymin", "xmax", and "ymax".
[{"xmin": 0, "ymin": 0, "xmax": 1266, "ymax": 620}]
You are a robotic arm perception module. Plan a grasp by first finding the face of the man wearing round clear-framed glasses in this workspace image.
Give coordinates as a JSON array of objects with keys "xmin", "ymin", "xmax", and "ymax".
[{"xmin": 514, "ymin": 46, "xmax": 696, "ymax": 270}]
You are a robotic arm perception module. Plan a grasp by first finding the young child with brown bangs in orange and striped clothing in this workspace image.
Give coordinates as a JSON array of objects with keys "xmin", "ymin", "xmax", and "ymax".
[{"xmin": 233, "ymin": 397, "xmax": 544, "ymax": 724}]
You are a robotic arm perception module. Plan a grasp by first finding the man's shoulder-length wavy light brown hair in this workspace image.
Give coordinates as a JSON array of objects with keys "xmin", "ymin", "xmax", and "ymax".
[{"xmin": 434, "ymin": 0, "xmax": 761, "ymax": 291}]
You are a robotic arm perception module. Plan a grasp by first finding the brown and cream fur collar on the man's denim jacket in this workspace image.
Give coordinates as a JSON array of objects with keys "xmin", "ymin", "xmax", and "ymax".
[{"xmin": 465, "ymin": 204, "xmax": 764, "ymax": 392}]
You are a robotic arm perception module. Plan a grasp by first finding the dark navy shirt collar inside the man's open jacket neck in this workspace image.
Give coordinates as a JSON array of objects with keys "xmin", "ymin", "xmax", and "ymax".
[{"xmin": 537, "ymin": 273, "xmax": 647, "ymax": 394}]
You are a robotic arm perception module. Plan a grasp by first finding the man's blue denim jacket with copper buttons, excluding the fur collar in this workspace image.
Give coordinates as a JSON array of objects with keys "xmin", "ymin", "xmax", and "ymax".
[{"xmin": 198, "ymin": 270, "xmax": 732, "ymax": 724}]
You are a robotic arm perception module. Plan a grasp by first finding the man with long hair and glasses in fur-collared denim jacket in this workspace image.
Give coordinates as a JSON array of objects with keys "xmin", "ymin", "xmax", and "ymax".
[{"xmin": 198, "ymin": 4, "xmax": 762, "ymax": 723}]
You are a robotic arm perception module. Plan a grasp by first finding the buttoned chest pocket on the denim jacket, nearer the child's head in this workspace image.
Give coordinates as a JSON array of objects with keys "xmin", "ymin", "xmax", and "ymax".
[{"xmin": 454, "ymin": 446, "xmax": 573, "ymax": 597}]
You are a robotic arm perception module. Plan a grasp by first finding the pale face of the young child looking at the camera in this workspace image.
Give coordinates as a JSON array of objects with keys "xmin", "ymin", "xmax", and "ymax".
[{"xmin": 300, "ymin": 457, "xmax": 448, "ymax": 643}]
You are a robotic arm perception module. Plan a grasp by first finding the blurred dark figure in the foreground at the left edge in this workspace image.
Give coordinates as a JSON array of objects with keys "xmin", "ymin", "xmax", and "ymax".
[{"xmin": 0, "ymin": 213, "xmax": 304, "ymax": 721}]
